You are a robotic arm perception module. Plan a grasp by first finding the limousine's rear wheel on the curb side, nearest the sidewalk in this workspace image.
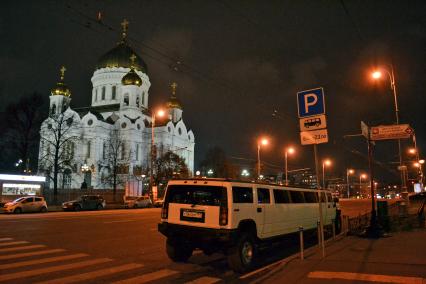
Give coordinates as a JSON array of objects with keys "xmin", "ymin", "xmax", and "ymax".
[{"xmin": 228, "ymin": 233, "xmax": 257, "ymax": 273}]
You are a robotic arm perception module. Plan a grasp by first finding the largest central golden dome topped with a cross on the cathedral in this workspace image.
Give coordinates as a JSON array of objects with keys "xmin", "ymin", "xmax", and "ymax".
[{"xmin": 96, "ymin": 20, "xmax": 148, "ymax": 74}]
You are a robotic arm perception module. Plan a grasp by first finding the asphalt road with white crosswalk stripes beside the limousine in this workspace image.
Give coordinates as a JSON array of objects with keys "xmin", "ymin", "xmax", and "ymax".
[{"xmin": 0, "ymin": 199, "xmax": 380, "ymax": 283}]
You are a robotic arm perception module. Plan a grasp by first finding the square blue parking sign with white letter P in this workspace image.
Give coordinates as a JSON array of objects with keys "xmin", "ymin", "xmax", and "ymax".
[{"xmin": 297, "ymin": 88, "xmax": 325, "ymax": 118}]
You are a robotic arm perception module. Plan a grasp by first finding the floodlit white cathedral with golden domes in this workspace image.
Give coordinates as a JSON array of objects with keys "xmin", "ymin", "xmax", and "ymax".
[{"xmin": 39, "ymin": 20, "xmax": 195, "ymax": 189}]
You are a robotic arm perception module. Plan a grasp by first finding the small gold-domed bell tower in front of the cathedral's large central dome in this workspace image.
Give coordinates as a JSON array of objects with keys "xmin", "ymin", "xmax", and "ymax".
[{"xmin": 120, "ymin": 54, "xmax": 142, "ymax": 110}]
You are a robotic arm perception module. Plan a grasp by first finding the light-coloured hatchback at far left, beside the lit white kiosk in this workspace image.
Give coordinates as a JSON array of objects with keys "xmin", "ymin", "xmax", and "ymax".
[{"xmin": 2, "ymin": 196, "xmax": 47, "ymax": 213}]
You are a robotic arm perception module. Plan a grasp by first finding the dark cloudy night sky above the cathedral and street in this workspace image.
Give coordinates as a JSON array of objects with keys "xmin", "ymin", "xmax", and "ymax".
[{"xmin": 0, "ymin": 0, "xmax": 426, "ymax": 181}]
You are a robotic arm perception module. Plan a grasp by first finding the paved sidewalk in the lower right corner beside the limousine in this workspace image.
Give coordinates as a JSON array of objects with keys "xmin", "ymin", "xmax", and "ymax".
[{"xmin": 256, "ymin": 229, "xmax": 426, "ymax": 284}]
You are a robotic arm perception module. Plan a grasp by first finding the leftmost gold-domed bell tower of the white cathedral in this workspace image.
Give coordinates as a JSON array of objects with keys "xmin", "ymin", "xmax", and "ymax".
[{"xmin": 49, "ymin": 66, "xmax": 71, "ymax": 115}]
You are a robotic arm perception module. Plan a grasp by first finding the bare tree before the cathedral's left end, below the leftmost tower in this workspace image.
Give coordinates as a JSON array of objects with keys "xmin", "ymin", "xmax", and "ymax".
[{"xmin": 39, "ymin": 111, "xmax": 79, "ymax": 199}]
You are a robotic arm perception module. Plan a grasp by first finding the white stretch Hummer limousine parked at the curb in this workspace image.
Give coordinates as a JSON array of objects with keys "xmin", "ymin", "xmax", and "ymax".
[{"xmin": 158, "ymin": 179, "xmax": 340, "ymax": 272}]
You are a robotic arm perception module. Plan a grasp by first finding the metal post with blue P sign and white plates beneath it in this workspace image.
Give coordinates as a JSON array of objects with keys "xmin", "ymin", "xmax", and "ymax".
[{"xmin": 297, "ymin": 88, "xmax": 328, "ymax": 257}]
